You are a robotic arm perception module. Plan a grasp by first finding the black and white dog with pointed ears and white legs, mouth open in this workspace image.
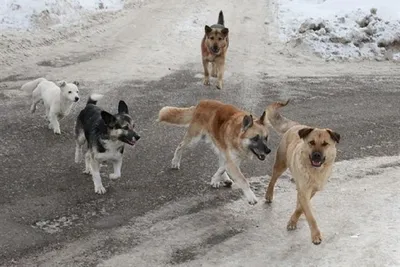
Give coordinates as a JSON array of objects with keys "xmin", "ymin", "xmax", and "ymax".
[{"xmin": 75, "ymin": 94, "xmax": 140, "ymax": 194}]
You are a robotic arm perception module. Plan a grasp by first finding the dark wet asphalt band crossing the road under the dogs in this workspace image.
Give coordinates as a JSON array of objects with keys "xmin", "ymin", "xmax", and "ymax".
[{"xmin": 0, "ymin": 69, "xmax": 400, "ymax": 266}]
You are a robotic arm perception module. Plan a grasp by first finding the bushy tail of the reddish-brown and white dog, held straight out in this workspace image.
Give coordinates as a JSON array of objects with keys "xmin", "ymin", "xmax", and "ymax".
[{"xmin": 157, "ymin": 106, "xmax": 196, "ymax": 126}]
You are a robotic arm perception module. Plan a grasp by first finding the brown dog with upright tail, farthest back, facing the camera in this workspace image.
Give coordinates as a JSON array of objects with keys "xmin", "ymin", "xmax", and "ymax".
[{"xmin": 201, "ymin": 10, "xmax": 229, "ymax": 89}]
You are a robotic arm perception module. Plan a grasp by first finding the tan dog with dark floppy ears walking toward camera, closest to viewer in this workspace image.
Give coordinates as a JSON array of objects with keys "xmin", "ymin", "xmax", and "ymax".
[{"xmin": 265, "ymin": 101, "xmax": 340, "ymax": 245}]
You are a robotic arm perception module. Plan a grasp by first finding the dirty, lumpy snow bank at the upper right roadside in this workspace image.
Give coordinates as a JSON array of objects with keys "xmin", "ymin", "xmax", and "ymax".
[{"xmin": 278, "ymin": 0, "xmax": 400, "ymax": 60}]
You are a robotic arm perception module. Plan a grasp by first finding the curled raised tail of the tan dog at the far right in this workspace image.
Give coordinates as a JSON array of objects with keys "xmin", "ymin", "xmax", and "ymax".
[{"xmin": 265, "ymin": 100, "xmax": 299, "ymax": 134}]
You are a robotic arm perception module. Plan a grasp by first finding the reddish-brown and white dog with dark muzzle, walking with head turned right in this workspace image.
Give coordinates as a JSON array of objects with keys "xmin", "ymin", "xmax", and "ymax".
[{"xmin": 158, "ymin": 100, "xmax": 271, "ymax": 205}]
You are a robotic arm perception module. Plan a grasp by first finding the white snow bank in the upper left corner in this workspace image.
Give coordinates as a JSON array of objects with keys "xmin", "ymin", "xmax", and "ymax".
[{"xmin": 0, "ymin": 0, "xmax": 124, "ymax": 29}]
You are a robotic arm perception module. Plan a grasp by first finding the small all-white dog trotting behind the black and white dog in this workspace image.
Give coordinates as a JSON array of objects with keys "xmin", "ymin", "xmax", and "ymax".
[{"xmin": 21, "ymin": 78, "xmax": 79, "ymax": 134}]
